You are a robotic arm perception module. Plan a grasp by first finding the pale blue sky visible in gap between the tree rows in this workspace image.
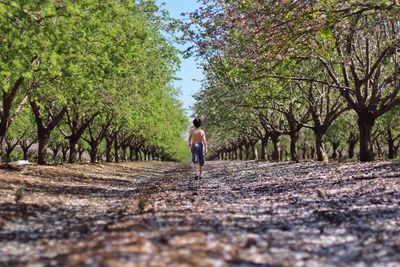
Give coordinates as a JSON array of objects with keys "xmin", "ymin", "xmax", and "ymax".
[{"xmin": 156, "ymin": 0, "xmax": 203, "ymax": 115}]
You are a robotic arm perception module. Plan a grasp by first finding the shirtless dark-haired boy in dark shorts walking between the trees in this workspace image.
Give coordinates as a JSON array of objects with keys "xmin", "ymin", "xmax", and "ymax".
[{"xmin": 188, "ymin": 118, "xmax": 207, "ymax": 178}]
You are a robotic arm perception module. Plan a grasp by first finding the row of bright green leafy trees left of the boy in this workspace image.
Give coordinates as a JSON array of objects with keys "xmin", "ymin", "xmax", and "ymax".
[{"xmin": 0, "ymin": 0, "xmax": 191, "ymax": 164}]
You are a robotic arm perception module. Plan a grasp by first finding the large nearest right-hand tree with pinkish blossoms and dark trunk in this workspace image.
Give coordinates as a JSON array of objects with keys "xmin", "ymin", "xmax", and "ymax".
[{"xmin": 184, "ymin": 0, "xmax": 400, "ymax": 161}]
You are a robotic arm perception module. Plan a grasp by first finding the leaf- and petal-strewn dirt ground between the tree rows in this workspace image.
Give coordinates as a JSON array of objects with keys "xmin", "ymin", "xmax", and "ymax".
[{"xmin": 0, "ymin": 162, "xmax": 400, "ymax": 266}]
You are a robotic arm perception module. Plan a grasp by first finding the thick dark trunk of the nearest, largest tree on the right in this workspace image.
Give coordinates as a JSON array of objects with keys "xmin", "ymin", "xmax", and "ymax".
[{"xmin": 358, "ymin": 114, "xmax": 375, "ymax": 162}]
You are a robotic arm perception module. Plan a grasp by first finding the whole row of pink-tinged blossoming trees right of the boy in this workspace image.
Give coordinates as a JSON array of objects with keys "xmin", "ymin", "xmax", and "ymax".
[{"xmin": 183, "ymin": 0, "xmax": 400, "ymax": 161}]
